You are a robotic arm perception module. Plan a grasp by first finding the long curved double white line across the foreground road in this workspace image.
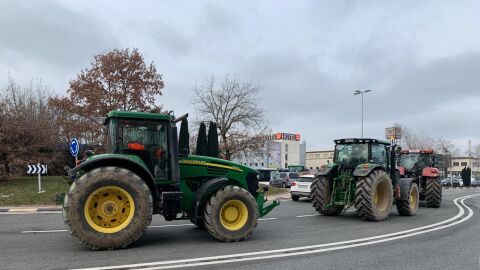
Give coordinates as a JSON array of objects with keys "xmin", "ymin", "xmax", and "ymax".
[{"xmin": 69, "ymin": 194, "xmax": 480, "ymax": 270}]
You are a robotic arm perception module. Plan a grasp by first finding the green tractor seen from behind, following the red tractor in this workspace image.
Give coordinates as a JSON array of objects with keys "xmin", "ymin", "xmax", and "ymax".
[{"xmin": 311, "ymin": 139, "xmax": 419, "ymax": 221}]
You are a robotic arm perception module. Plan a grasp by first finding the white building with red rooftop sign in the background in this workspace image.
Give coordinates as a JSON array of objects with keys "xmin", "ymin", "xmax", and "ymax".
[{"xmin": 234, "ymin": 132, "xmax": 307, "ymax": 169}]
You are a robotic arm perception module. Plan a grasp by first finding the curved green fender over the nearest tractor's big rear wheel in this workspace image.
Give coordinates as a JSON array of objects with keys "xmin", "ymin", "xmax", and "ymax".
[{"xmin": 68, "ymin": 156, "xmax": 160, "ymax": 213}]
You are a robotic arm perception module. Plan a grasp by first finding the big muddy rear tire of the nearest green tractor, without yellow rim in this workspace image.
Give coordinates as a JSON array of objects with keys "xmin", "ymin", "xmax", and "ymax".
[{"xmin": 63, "ymin": 167, "xmax": 153, "ymax": 250}]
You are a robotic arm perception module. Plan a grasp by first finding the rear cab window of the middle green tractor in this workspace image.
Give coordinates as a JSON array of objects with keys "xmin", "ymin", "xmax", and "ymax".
[{"xmin": 334, "ymin": 143, "xmax": 368, "ymax": 168}]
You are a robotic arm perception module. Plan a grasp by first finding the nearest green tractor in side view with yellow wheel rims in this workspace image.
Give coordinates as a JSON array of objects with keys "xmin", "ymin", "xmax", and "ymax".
[{"xmin": 63, "ymin": 111, "xmax": 279, "ymax": 250}]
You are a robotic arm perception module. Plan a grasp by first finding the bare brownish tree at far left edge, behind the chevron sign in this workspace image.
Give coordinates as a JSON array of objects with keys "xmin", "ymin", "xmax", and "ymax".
[{"xmin": 0, "ymin": 78, "xmax": 58, "ymax": 178}]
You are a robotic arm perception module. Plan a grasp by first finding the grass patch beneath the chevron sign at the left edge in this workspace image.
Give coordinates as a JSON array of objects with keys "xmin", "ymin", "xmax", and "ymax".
[{"xmin": 0, "ymin": 176, "xmax": 70, "ymax": 206}]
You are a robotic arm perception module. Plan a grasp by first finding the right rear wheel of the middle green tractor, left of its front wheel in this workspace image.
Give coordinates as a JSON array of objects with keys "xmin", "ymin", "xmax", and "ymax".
[{"xmin": 355, "ymin": 170, "xmax": 393, "ymax": 221}]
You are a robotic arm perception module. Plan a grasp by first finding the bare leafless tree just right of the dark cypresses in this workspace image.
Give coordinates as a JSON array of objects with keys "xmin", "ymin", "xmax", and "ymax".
[{"xmin": 193, "ymin": 74, "xmax": 268, "ymax": 160}]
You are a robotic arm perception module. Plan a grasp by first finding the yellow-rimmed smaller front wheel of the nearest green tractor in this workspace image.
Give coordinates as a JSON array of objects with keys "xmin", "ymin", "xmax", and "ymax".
[{"xmin": 203, "ymin": 186, "xmax": 259, "ymax": 242}]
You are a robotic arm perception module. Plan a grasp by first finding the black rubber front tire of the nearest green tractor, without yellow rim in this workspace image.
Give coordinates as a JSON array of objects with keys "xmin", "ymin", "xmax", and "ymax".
[{"xmin": 204, "ymin": 186, "xmax": 259, "ymax": 242}]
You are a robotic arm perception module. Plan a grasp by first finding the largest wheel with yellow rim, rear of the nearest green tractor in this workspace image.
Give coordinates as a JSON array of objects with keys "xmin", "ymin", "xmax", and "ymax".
[{"xmin": 63, "ymin": 167, "xmax": 153, "ymax": 250}]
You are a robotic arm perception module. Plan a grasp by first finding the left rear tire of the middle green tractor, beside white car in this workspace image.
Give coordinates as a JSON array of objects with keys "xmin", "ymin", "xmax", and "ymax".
[{"xmin": 310, "ymin": 176, "xmax": 344, "ymax": 216}]
